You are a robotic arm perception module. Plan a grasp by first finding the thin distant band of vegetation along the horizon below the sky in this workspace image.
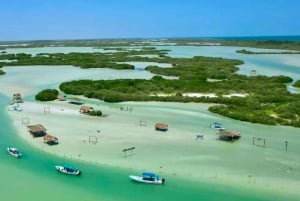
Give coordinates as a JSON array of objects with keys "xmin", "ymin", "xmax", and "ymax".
[{"xmin": 0, "ymin": 38, "xmax": 300, "ymax": 51}]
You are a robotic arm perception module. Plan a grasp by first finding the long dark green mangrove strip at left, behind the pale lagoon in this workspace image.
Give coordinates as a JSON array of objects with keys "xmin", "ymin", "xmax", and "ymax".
[{"xmin": 0, "ymin": 48, "xmax": 167, "ymax": 69}]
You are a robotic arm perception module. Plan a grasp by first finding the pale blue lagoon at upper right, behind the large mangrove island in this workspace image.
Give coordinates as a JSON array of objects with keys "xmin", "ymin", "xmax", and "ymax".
[{"xmin": 156, "ymin": 46, "xmax": 300, "ymax": 80}]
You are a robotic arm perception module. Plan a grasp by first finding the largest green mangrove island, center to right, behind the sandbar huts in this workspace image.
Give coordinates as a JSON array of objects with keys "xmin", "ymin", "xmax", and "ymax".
[{"xmin": 56, "ymin": 52, "xmax": 300, "ymax": 127}]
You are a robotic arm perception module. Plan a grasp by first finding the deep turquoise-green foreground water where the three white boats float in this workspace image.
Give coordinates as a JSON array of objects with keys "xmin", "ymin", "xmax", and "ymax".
[{"xmin": 0, "ymin": 93, "xmax": 299, "ymax": 201}]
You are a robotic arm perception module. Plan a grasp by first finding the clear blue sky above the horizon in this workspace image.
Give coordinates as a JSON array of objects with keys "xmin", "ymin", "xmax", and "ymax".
[{"xmin": 0, "ymin": 0, "xmax": 300, "ymax": 41}]
